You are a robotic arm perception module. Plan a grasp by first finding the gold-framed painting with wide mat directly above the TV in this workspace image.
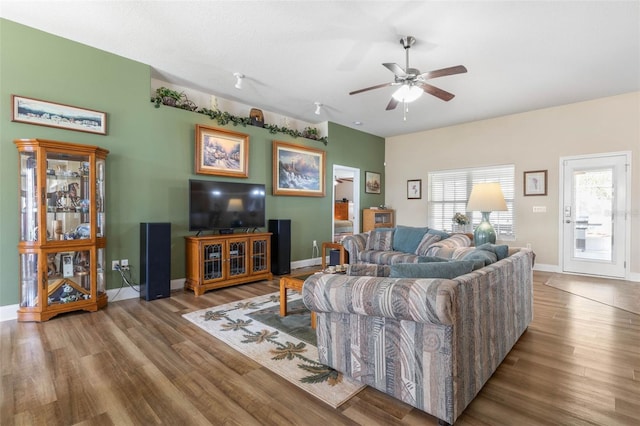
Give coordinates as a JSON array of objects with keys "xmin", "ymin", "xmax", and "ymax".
[{"xmin": 195, "ymin": 124, "xmax": 249, "ymax": 178}]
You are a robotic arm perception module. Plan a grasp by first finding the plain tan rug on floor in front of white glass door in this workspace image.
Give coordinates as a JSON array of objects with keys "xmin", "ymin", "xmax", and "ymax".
[{"xmin": 544, "ymin": 274, "xmax": 640, "ymax": 315}]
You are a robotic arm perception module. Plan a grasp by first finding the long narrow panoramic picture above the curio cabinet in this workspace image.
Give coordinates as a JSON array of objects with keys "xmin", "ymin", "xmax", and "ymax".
[{"xmin": 11, "ymin": 95, "xmax": 107, "ymax": 135}]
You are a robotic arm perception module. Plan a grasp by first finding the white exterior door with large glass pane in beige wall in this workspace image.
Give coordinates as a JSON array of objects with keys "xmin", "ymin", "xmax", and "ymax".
[{"xmin": 560, "ymin": 152, "xmax": 631, "ymax": 278}]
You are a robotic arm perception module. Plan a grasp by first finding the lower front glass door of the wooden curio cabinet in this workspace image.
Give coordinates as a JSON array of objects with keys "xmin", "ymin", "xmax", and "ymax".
[{"xmin": 46, "ymin": 250, "xmax": 91, "ymax": 306}]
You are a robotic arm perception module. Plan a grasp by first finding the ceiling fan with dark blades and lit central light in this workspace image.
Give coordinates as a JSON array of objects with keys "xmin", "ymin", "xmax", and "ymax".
[{"xmin": 349, "ymin": 36, "xmax": 467, "ymax": 111}]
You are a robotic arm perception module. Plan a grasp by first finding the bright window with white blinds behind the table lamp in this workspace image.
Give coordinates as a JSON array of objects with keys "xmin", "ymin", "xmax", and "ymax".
[{"xmin": 428, "ymin": 164, "xmax": 515, "ymax": 240}]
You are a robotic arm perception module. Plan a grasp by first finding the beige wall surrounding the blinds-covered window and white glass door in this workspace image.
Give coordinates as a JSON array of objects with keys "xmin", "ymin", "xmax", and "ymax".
[{"xmin": 385, "ymin": 92, "xmax": 640, "ymax": 275}]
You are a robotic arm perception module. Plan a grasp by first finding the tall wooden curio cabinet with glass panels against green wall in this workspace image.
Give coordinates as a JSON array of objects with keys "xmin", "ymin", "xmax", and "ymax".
[{"xmin": 14, "ymin": 139, "xmax": 109, "ymax": 321}]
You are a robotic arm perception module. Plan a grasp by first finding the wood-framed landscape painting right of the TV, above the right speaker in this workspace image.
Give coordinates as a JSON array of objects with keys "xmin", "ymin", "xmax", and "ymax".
[{"xmin": 273, "ymin": 141, "xmax": 326, "ymax": 197}]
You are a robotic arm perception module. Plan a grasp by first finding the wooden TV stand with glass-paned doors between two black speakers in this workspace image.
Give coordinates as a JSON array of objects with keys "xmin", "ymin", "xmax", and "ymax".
[{"xmin": 184, "ymin": 232, "xmax": 273, "ymax": 296}]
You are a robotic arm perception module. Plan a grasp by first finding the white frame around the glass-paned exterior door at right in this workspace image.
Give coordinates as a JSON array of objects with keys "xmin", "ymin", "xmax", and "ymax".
[{"xmin": 558, "ymin": 151, "xmax": 633, "ymax": 280}]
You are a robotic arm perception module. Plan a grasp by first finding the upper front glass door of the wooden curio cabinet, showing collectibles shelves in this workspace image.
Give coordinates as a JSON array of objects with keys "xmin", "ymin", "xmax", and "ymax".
[{"xmin": 45, "ymin": 152, "xmax": 91, "ymax": 241}]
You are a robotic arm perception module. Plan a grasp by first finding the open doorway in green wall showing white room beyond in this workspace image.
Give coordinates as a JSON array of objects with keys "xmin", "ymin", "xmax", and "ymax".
[{"xmin": 331, "ymin": 164, "xmax": 360, "ymax": 243}]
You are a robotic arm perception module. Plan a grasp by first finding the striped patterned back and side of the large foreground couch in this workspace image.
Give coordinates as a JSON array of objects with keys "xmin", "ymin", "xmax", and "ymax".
[{"xmin": 302, "ymin": 249, "xmax": 534, "ymax": 424}]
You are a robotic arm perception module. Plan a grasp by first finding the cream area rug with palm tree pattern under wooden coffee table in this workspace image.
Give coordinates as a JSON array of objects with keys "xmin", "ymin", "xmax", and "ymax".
[{"xmin": 183, "ymin": 293, "xmax": 365, "ymax": 408}]
